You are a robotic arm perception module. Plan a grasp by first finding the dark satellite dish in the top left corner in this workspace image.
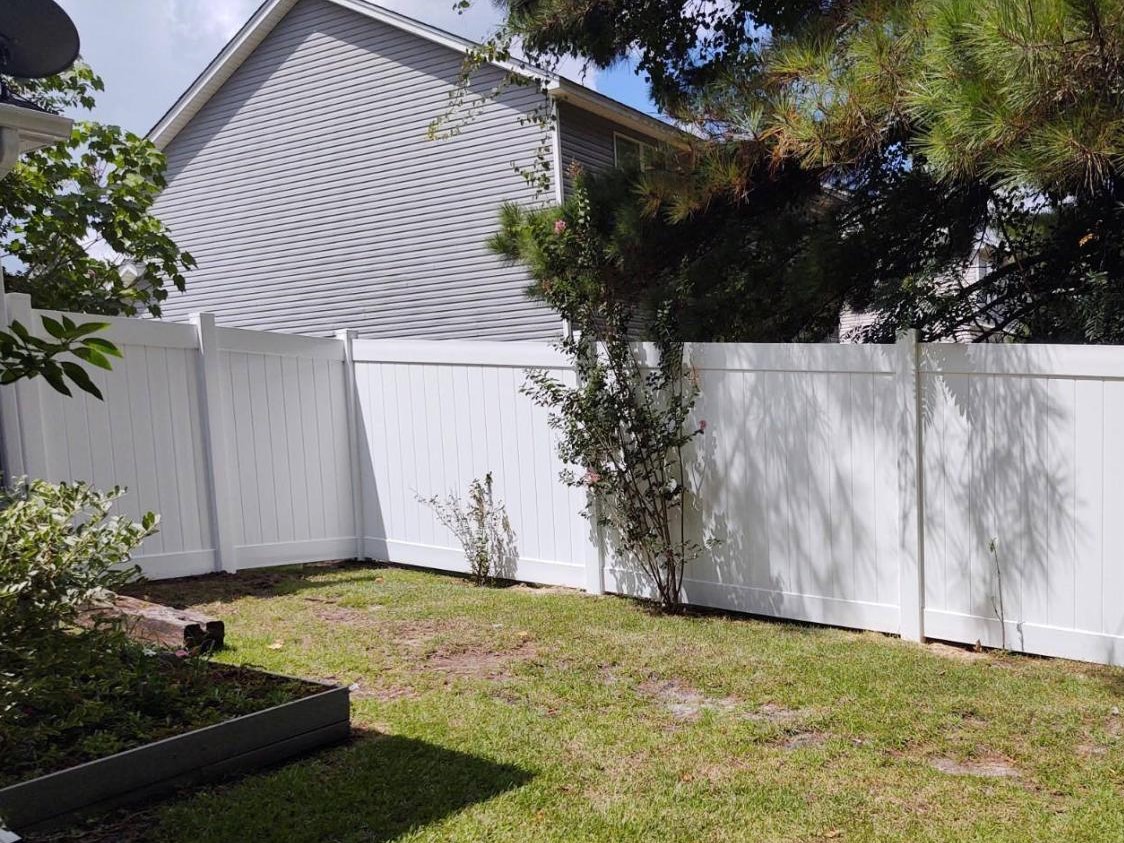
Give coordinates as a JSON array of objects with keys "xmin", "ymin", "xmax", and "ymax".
[{"xmin": 0, "ymin": 0, "xmax": 79, "ymax": 79}]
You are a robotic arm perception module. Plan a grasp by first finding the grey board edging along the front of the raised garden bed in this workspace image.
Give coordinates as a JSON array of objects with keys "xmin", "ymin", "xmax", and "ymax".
[{"xmin": 0, "ymin": 682, "xmax": 351, "ymax": 833}]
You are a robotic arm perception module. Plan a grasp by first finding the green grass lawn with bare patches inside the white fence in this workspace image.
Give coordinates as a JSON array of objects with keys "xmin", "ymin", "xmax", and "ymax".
[{"xmin": 43, "ymin": 566, "xmax": 1124, "ymax": 843}]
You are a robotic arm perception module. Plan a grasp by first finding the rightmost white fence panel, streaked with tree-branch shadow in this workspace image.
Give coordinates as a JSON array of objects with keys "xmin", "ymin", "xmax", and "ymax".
[{"xmin": 921, "ymin": 345, "xmax": 1124, "ymax": 663}]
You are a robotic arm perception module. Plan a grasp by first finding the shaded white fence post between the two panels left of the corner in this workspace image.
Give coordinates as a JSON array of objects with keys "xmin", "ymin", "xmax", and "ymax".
[{"xmin": 191, "ymin": 314, "xmax": 238, "ymax": 573}]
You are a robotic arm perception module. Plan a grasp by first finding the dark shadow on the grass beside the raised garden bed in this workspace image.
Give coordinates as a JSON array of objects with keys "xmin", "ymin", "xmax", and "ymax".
[{"xmin": 41, "ymin": 731, "xmax": 534, "ymax": 843}]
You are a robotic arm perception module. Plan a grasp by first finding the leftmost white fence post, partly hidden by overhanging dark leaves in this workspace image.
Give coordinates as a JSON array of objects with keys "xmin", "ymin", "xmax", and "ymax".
[{"xmin": 0, "ymin": 292, "xmax": 51, "ymax": 479}]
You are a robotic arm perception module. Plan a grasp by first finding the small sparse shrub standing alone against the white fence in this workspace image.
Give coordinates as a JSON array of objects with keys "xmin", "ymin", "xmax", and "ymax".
[{"xmin": 418, "ymin": 471, "xmax": 519, "ymax": 586}]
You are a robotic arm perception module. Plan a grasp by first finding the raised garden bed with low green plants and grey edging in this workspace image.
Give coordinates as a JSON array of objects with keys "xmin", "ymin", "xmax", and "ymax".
[{"xmin": 0, "ymin": 653, "xmax": 350, "ymax": 832}]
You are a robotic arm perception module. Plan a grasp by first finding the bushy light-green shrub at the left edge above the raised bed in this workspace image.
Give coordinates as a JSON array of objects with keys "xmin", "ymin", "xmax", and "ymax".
[{"xmin": 0, "ymin": 479, "xmax": 158, "ymax": 647}]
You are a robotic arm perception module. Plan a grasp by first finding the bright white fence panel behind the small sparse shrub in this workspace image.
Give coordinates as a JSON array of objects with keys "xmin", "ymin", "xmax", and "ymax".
[{"xmin": 355, "ymin": 341, "xmax": 597, "ymax": 587}]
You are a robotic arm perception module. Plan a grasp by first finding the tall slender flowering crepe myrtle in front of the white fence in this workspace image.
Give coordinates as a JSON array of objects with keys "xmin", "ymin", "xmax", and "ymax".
[{"xmin": 490, "ymin": 172, "xmax": 708, "ymax": 611}]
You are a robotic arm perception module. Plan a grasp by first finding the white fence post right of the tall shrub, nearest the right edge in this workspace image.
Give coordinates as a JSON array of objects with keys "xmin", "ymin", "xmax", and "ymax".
[{"xmin": 894, "ymin": 330, "xmax": 925, "ymax": 641}]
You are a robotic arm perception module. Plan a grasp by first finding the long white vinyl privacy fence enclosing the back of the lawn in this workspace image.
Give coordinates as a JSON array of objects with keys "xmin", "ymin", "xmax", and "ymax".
[{"xmin": 0, "ymin": 294, "xmax": 1124, "ymax": 664}]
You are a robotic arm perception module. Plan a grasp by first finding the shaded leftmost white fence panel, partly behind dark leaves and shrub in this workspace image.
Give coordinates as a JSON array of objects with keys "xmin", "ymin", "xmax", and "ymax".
[{"xmin": 13, "ymin": 308, "xmax": 215, "ymax": 577}]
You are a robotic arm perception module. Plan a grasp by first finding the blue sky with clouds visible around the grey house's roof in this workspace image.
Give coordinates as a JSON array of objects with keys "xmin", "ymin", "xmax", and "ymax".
[{"xmin": 58, "ymin": 0, "xmax": 654, "ymax": 134}]
